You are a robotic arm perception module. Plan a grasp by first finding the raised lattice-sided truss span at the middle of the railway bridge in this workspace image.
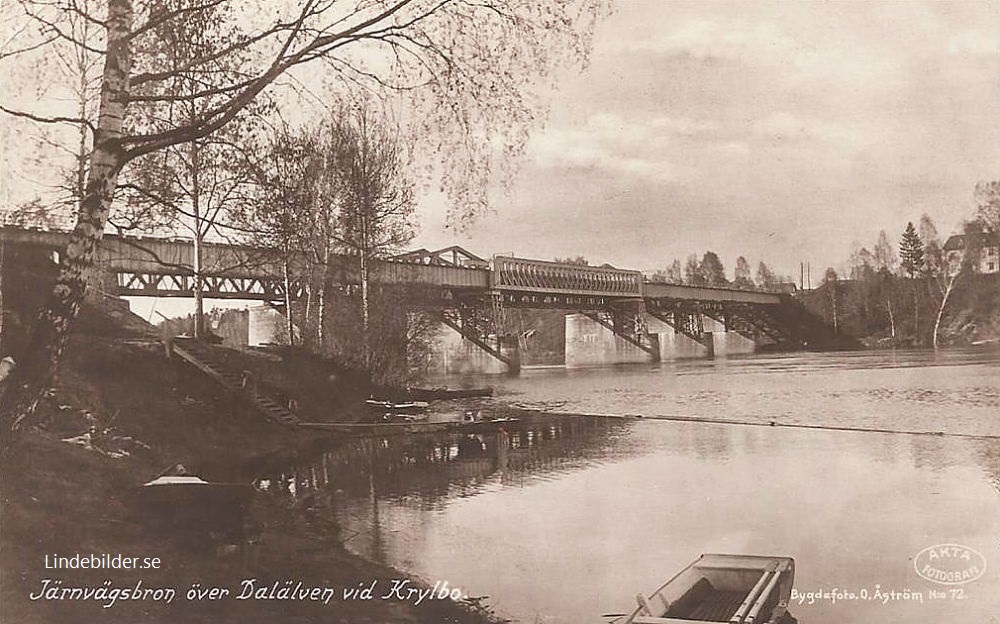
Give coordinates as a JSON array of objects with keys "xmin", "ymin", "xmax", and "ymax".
[{"xmin": 491, "ymin": 256, "xmax": 642, "ymax": 297}]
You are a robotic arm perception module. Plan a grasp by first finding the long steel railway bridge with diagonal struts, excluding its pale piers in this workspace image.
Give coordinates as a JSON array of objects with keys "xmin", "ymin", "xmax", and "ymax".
[{"xmin": 0, "ymin": 227, "xmax": 822, "ymax": 368}]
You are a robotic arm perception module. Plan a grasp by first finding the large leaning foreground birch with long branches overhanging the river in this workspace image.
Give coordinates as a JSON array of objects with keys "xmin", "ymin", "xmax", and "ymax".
[{"xmin": 0, "ymin": 0, "xmax": 606, "ymax": 448}]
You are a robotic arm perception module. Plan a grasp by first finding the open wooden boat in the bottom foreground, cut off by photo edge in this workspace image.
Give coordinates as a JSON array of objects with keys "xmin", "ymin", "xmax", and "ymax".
[{"xmin": 621, "ymin": 554, "xmax": 795, "ymax": 624}]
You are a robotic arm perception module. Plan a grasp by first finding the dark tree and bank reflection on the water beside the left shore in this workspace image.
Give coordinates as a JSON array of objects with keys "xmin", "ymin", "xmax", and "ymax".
[{"xmin": 258, "ymin": 417, "xmax": 631, "ymax": 508}]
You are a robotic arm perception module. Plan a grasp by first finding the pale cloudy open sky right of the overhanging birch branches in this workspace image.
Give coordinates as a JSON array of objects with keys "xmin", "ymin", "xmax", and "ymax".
[{"xmin": 414, "ymin": 0, "xmax": 1000, "ymax": 283}]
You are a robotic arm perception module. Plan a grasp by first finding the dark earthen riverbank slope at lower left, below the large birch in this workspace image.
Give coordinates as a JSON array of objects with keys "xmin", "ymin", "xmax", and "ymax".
[{"xmin": 0, "ymin": 329, "xmax": 504, "ymax": 624}]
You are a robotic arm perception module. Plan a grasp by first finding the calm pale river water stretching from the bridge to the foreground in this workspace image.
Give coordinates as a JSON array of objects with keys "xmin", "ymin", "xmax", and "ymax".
[{"xmin": 267, "ymin": 349, "xmax": 1000, "ymax": 624}]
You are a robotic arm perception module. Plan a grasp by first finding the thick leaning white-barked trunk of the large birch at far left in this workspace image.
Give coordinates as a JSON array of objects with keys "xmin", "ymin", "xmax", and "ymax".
[{"xmin": 0, "ymin": 0, "xmax": 133, "ymax": 450}]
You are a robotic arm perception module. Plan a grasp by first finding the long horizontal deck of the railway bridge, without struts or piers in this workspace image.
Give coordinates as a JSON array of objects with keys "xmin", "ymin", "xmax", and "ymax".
[{"xmin": 0, "ymin": 227, "xmax": 782, "ymax": 307}]
